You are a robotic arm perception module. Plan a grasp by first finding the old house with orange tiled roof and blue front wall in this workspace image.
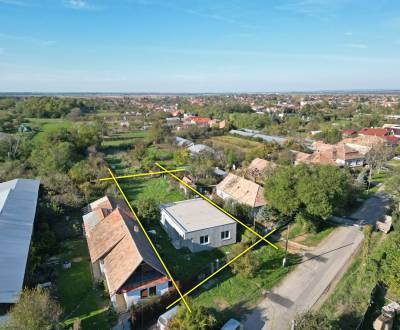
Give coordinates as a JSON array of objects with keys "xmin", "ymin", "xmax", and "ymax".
[{"xmin": 83, "ymin": 196, "xmax": 171, "ymax": 312}]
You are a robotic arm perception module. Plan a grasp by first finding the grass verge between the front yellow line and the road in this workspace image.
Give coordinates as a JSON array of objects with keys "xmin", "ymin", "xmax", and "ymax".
[{"xmin": 193, "ymin": 246, "xmax": 299, "ymax": 322}]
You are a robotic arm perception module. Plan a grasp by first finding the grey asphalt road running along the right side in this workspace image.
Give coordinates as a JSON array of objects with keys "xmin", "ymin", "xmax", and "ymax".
[{"xmin": 244, "ymin": 192, "xmax": 387, "ymax": 330}]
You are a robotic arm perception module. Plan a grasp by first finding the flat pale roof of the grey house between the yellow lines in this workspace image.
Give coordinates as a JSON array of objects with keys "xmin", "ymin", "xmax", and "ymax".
[{"xmin": 161, "ymin": 198, "xmax": 235, "ymax": 233}]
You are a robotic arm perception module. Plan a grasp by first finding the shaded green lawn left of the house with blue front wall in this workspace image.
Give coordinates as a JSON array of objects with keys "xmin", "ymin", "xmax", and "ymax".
[{"xmin": 57, "ymin": 240, "xmax": 115, "ymax": 330}]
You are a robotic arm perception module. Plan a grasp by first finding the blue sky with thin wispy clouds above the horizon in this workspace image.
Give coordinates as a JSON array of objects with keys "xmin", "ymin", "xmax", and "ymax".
[{"xmin": 0, "ymin": 0, "xmax": 400, "ymax": 92}]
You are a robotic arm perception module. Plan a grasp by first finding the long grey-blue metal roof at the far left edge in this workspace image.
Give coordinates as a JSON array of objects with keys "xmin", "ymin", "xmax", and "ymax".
[{"xmin": 0, "ymin": 179, "xmax": 40, "ymax": 303}]
